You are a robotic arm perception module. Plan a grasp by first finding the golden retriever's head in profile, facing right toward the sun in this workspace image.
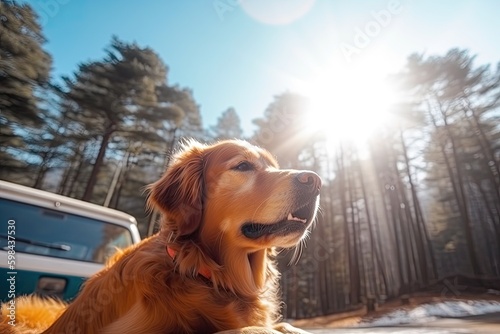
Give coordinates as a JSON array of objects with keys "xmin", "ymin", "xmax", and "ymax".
[{"xmin": 149, "ymin": 140, "xmax": 321, "ymax": 251}]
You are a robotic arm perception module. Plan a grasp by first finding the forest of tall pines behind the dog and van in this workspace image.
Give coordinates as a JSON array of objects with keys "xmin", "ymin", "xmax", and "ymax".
[{"xmin": 0, "ymin": 1, "xmax": 500, "ymax": 318}]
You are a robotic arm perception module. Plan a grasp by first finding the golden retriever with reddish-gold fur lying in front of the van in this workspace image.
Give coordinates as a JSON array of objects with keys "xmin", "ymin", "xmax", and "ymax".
[{"xmin": 0, "ymin": 140, "xmax": 321, "ymax": 334}]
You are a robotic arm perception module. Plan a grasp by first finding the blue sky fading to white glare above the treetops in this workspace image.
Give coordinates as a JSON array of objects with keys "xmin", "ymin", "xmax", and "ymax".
[{"xmin": 27, "ymin": 0, "xmax": 500, "ymax": 135}]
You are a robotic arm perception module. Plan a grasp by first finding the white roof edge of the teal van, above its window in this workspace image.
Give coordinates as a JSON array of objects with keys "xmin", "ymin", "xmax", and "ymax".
[{"xmin": 0, "ymin": 180, "xmax": 137, "ymax": 225}]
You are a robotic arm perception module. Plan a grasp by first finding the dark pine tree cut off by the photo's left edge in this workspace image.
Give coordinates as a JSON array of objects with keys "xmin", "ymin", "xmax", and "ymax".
[{"xmin": 0, "ymin": 1, "xmax": 52, "ymax": 174}]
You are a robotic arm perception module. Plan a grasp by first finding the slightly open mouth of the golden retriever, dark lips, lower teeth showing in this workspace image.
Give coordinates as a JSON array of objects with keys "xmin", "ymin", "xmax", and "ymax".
[{"xmin": 241, "ymin": 201, "xmax": 316, "ymax": 239}]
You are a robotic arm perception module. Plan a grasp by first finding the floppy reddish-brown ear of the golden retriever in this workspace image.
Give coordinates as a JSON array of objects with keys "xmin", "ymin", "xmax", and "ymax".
[{"xmin": 148, "ymin": 142, "xmax": 204, "ymax": 236}]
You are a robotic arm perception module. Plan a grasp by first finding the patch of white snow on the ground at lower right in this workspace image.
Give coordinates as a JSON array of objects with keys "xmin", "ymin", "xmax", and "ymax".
[{"xmin": 358, "ymin": 300, "xmax": 500, "ymax": 327}]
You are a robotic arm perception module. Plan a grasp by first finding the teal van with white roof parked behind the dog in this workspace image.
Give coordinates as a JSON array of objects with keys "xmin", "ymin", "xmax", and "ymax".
[{"xmin": 0, "ymin": 181, "xmax": 140, "ymax": 301}]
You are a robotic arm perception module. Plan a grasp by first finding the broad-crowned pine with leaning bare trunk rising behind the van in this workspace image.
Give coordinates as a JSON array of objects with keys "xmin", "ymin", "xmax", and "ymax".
[{"xmin": 59, "ymin": 38, "xmax": 166, "ymax": 201}]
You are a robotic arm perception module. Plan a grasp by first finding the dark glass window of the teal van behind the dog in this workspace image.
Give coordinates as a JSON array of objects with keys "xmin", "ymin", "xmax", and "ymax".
[{"xmin": 0, "ymin": 198, "xmax": 133, "ymax": 263}]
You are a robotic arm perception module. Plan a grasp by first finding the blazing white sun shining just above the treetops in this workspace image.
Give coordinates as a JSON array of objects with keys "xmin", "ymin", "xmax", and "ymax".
[{"xmin": 302, "ymin": 61, "xmax": 397, "ymax": 146}]
